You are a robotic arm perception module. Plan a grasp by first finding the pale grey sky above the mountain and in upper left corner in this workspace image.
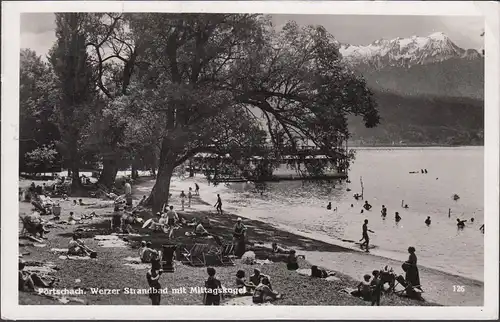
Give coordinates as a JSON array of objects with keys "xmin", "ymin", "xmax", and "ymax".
[{"xmin": 21, "ymin": 13, "xmax": 484, "ymax": 56}]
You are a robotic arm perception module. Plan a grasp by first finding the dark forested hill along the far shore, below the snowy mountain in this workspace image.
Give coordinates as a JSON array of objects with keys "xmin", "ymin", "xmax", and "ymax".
[{"xmin": 349, "ymin": 91, "xmax": 484, "ymax": 145}]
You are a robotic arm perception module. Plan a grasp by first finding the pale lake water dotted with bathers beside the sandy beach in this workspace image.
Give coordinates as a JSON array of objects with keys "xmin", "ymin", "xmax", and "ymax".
[{"xmin": 204, "ymin": 147, "xmax": 484, "ymax": 281}]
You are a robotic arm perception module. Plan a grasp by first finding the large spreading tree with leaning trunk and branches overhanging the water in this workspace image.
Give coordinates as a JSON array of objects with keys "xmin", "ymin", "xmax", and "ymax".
[{"xmin": 124, "ymin": 14, "xmax": 379, "ymax": 211}]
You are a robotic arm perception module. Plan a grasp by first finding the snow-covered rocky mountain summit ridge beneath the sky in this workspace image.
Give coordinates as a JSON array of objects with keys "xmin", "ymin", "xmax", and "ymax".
[{"xmin": 339, "ymin": 32, "xmax": 481, "ymax": 69}]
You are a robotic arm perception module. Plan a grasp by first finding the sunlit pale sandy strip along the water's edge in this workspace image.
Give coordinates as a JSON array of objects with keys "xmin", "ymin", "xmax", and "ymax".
[{"xmin": 165, "ymin": 178, "xmax": 484, "ymax": 306}]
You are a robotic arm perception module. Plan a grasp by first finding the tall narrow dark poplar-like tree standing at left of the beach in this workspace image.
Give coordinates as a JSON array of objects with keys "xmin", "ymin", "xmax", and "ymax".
[{"xmin": 49, "ymin": 13, "xmax": 98, "ymax": 191}]
